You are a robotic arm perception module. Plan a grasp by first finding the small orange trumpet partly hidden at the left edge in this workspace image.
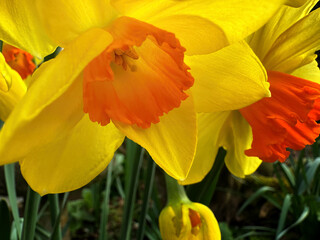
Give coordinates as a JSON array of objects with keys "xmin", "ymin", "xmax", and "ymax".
[{"xmin": 2, "ymin": 44, "xmax": 36, "ymax": 79}]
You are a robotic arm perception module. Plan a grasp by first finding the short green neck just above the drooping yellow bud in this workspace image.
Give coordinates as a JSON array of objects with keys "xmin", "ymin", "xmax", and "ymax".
[{"xmin": 165, "ymin": 173, "xmax": 190, "ymax": 205}]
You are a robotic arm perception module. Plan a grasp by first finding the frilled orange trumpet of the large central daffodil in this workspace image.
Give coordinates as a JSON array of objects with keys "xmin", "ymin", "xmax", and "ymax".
[{"xmin": 83, "ymin": 17, "xmax": 194, "ymax": 128}]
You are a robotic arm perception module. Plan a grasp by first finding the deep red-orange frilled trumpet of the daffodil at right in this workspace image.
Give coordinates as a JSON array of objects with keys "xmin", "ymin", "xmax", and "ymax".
[{"xmin": 240, "ymin": 71, "xmax": 320, "ymax": 162}]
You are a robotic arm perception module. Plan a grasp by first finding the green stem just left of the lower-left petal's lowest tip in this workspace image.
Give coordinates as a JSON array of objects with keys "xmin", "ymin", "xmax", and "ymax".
[{"xmin": 22, "ymin": 187, "xmax": 41, "ymax": 240}]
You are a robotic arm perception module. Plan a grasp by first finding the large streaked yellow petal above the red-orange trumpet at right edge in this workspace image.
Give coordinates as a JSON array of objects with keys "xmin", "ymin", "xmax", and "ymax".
[{"xmin": 263, "ymin": 9, "xmax": 320, "ymax": 73}]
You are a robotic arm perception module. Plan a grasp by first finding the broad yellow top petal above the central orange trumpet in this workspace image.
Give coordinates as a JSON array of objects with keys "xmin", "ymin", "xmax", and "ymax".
[{"xmin": 111, "ymin": 0, "xmax": 285, "ymax": 54}]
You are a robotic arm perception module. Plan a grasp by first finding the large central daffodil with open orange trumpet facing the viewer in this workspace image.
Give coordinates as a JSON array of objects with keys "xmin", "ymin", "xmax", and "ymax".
[{"xmin": 0, "ymin": 0, "xmax": 296, "ymax": 194}]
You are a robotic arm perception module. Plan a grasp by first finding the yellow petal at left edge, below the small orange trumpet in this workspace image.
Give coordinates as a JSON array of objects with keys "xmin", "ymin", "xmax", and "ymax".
[{"xmin": 0, "ymin": 53, "xmax": 27, "ymax": 121}]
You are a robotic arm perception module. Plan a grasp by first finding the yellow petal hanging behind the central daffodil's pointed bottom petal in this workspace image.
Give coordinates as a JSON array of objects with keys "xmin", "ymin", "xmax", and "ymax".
[{"xmin": 180, "ymin": 111, "xmax": 231, "ymax": 185}]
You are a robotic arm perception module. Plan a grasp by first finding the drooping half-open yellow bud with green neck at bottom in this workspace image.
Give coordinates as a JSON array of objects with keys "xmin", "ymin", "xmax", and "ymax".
[{"xmin": 159, "ymin": 176, "xmax": 221, "ymax": 240}]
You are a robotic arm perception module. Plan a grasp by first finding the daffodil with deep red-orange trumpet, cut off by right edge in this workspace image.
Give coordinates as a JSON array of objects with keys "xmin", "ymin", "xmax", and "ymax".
[{"xmin": 183, "ymin": 0, "xmax": 320, "ymax": 184}]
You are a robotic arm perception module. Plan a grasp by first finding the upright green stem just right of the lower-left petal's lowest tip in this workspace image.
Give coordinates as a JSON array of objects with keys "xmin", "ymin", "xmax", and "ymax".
[{"xmin": 48, "ymin": 194, "xmax": 62, "ymax": 240}]
